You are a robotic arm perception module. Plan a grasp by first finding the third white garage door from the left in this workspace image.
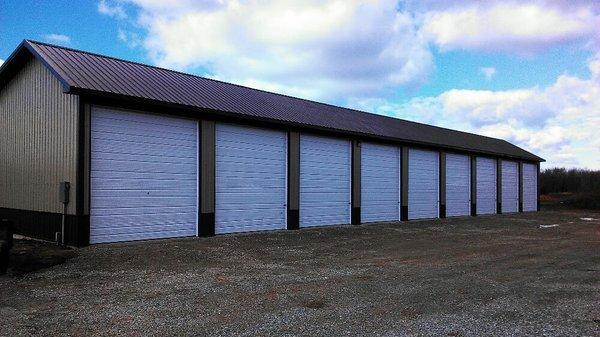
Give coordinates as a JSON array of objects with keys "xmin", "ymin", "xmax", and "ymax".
[{"xmin": 300, "ymin": 135, "xmax": 351, "ymax": 227}]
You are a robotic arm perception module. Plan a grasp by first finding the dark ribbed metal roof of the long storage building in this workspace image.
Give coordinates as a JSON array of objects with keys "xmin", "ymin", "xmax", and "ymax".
[{"xmin": 0, "ymin": 40, "xmax": 543, "ymax": 161}]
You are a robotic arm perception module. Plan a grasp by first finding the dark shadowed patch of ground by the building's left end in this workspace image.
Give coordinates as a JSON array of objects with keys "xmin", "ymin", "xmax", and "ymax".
[{"xmin": 6, "ymin": 239, "xmax": 77, "ymax": 277}]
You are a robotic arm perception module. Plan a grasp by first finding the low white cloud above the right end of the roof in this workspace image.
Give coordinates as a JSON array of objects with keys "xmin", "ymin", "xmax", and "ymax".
[{"xmin": 352, "ymin": 57, "xmax": 600, "ymax": 169}]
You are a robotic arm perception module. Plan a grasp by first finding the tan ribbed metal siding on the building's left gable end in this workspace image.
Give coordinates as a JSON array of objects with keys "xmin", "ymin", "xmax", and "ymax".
[{"xmin": 0, "ymin": 59, "xmax": 79, "ymax": 214}]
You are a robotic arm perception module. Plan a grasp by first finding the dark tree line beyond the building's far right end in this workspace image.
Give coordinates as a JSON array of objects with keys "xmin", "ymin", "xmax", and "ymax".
[{"xmin": 540, "ymin": 168, "xmax": 600, "ymax": 194}]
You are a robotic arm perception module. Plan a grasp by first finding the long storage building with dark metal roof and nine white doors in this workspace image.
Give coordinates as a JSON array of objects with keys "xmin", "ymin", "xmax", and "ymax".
[{"xmin": 0, "ymin": 41, "xmax": 543, "ymax": 246}]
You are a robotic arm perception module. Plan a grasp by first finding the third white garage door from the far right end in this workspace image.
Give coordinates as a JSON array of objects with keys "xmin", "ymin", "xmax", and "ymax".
[{"xmin": 477, "ymin": 157, "xmax": 497, "ymax": 214}]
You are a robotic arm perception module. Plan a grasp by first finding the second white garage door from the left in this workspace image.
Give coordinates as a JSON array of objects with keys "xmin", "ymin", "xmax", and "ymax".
[{"xmin": 215, "ymin": 123, "xmax": 287, "ymax": 234}]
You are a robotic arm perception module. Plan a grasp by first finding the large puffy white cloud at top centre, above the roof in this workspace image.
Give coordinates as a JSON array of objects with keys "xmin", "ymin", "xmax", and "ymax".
[{"xmin": 116, "ymin": 0, "xmax": 433, "ymax": 99}]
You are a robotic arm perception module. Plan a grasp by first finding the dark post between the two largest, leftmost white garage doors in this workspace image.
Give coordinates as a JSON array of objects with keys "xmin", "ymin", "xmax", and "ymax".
[{"xmin": 198, "ymin": 120, "xmax": 216, "ymax": 237}]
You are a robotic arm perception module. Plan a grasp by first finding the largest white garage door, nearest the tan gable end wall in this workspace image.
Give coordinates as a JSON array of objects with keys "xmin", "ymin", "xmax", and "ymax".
[{"xmin": 90, "ymin": 108, "xmax": 198, "ymax": 243}]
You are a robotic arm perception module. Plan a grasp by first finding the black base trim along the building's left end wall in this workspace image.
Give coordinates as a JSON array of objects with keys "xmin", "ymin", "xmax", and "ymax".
[{"xmin": 0, "ymin": 208, "xmax": 90, "ymax": 247}]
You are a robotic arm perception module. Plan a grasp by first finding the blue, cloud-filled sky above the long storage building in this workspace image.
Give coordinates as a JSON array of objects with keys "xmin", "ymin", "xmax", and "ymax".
[{"xmin": 0, "ymin": 0, "xmax": 600, "ymax": 169}]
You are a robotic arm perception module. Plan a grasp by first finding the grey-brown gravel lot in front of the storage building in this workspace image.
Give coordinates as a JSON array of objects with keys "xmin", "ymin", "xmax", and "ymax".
[{"xmin": 0, "ymin": 211, "xmax": 600, "ymax": 336}]
